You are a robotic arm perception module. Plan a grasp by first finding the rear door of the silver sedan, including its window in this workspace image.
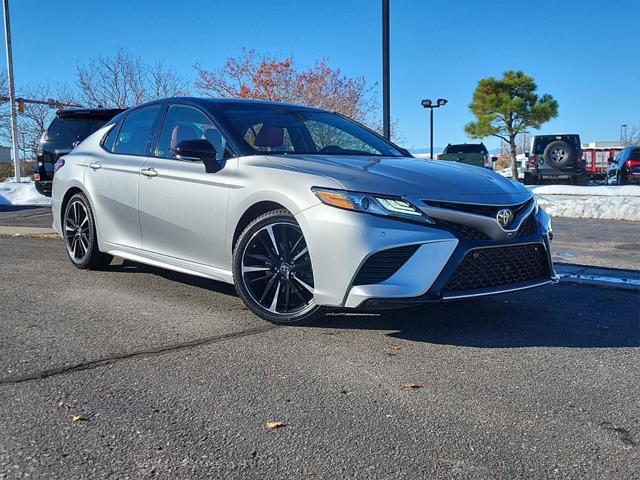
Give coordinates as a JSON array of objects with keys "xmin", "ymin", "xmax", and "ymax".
[{"xmin": 85, "ymin": 105, "xmax": 163, "ymax": 248}]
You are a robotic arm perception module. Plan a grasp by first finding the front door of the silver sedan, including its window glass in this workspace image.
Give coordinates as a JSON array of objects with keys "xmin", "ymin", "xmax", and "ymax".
[{"xmin": 139, "ymin": 104, "xmax": 236, "ymax": 268}]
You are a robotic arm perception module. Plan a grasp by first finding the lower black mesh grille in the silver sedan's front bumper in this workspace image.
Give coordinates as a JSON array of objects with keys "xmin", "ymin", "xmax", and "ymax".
[{"xmin": 444, "ymin": 244, "xmax": 550, "ymax": 292}]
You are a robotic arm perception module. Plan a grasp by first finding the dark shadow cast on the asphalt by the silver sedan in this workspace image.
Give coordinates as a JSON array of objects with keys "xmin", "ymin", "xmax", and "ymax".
[{"xmin": 108, "ymin": 260, "xmax": 640, "ymax": 348}]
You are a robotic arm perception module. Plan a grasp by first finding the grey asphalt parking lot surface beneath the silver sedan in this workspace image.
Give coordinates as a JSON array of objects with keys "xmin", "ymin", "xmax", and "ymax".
[{"xmin": 0, "ymin": 237, "xmax": 640, "ymax": 479}]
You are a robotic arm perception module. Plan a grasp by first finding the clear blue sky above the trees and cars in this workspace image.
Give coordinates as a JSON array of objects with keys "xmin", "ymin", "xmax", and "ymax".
[{"xmin": 2, "ymin": 0, "xmax": 640, "ymax": 149}]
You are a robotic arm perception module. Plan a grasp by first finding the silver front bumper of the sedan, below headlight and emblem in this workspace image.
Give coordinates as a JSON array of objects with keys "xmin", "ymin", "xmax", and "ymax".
[{"xmin": 296, "ymin": 205, "xmax": 555, "ymax": 308}]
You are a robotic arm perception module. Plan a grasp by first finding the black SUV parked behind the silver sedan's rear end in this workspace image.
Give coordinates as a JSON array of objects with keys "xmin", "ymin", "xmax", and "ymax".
[{"xmin": 33, "ymin": 108, "xmax": 124, "ymax": 197}]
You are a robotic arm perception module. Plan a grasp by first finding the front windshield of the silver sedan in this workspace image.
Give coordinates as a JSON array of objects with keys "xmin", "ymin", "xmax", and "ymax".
[{"xmin": 220, "ymin": 103, "xmax": 406, "ymax": 157}]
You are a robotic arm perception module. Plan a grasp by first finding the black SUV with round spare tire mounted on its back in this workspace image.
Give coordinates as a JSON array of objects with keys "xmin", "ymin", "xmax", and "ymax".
[{"xmin": 524, "ymin": 134, "xmax": 587, "ymax": 185}]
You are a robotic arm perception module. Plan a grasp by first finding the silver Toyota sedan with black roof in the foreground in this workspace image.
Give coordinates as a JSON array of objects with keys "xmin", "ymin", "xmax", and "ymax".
[{"xmin": 52, "ymin": 98, "xmax": 556, "ymax": 323}]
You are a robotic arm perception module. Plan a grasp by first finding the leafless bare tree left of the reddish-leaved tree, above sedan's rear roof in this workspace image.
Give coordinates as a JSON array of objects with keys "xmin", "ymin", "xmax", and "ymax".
[{"xmin": 76, "ymin": 48, "xmax": 189, "ymax": 108}]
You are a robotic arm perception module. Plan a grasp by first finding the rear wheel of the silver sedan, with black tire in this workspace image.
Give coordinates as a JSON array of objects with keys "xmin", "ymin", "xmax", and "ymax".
[{"xmin": 62, "ymin": 193, "xmax": 113, "ymax": 270}]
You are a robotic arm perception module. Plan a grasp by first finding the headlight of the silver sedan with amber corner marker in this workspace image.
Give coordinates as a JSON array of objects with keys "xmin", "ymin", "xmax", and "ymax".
[{"xmin": 311, "ymin": 187, "xmax": 434, "ymax": 223}]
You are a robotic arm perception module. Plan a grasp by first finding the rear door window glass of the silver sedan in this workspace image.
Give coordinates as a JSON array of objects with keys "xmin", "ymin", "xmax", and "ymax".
[{"xmin": 113, "ymin": 105, "xmax": 160, "ymax": 155}]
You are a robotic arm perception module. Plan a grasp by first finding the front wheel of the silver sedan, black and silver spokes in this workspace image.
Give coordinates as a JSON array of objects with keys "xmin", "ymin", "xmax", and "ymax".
[{"xmin": 233, "ymin": 210, "xmax": 320, "ymax": 324}]
